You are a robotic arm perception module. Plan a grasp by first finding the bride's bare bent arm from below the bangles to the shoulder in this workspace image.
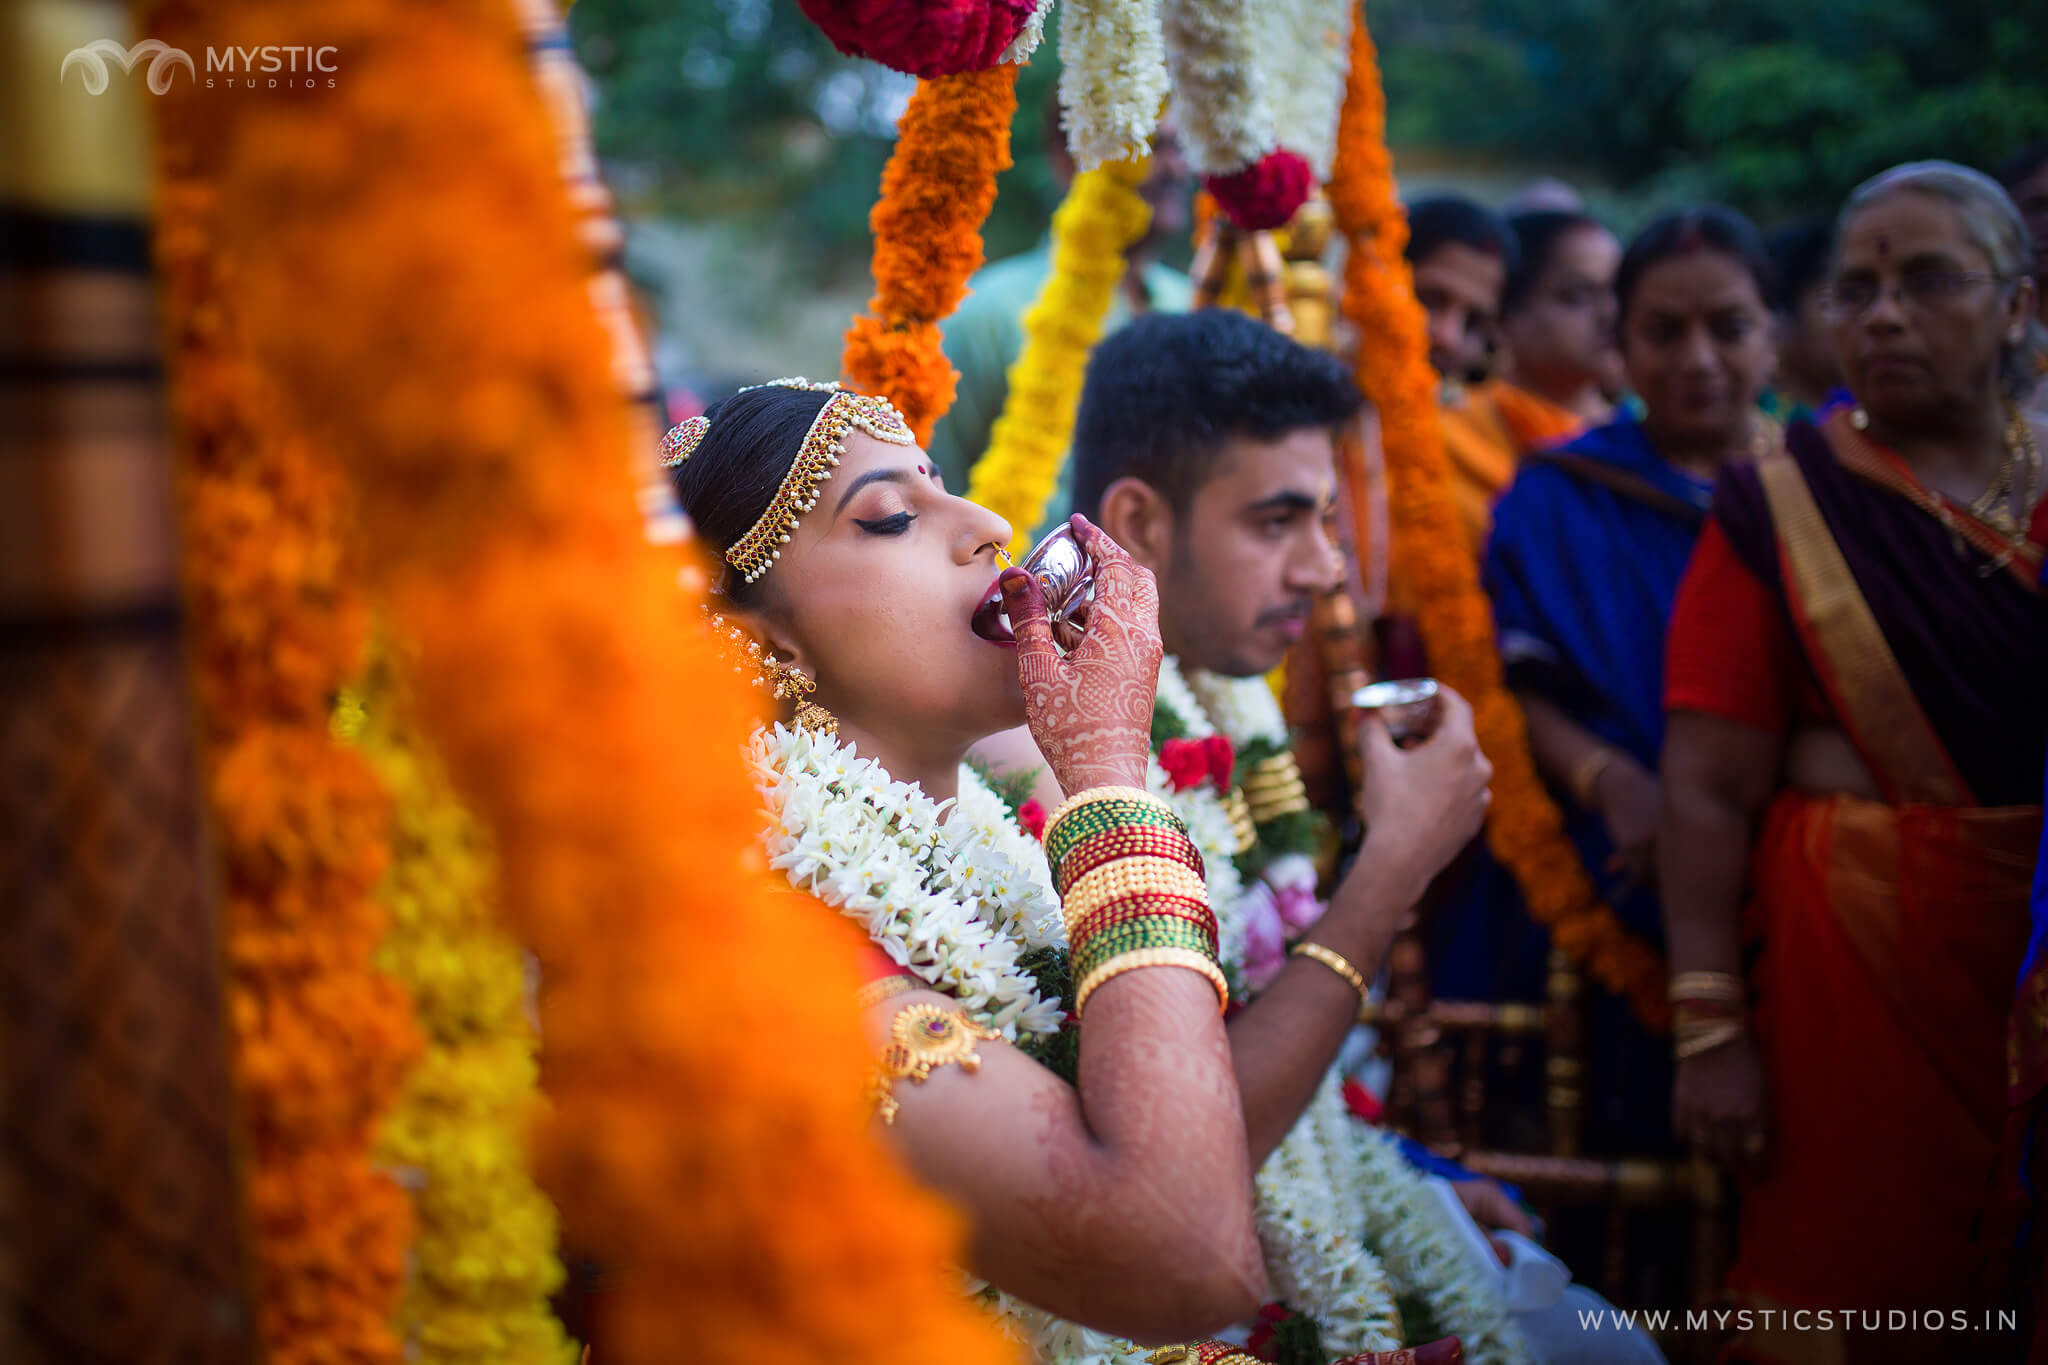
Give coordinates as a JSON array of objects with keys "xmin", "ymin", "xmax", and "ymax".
[{"xmin": 868, "ymin": 968, "xmax": 1268, "ymax": 1342}]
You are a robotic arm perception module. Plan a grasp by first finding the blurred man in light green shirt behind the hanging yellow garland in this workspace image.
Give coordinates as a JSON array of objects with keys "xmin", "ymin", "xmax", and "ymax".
[{"xmin": 926, "ymin": 100, "xmax": 1192, "ymax": 522}]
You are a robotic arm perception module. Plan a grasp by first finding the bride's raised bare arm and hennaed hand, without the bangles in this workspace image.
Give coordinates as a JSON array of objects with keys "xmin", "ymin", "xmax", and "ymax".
[{"xmin": 870, "ymin": 518, "xmax": 1266, "ymax": 1340}]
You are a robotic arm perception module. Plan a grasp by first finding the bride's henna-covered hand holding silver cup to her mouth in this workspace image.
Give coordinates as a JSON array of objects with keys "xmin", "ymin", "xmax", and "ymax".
[{"xmin": 1001, "ymin": 516, "xmax": 1161, "ymax": 796}]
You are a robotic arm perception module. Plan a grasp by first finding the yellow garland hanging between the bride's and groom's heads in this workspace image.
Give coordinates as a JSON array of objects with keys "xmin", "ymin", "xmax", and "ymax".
[{"xmin": 967, "ymin": 158, "xmax": 1151, "ymax": 555}]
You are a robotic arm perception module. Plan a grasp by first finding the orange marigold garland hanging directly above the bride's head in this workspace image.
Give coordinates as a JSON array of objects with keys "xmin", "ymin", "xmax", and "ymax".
[{"xmin": 840, "ymin": 63, "xmax": 1018, "ymax": 446}]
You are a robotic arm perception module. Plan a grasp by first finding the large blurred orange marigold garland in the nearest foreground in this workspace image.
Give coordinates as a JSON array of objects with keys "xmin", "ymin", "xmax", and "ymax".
[{"xmin": 201, "ymin": 0, "xmax": 1004, "ymax": 1365}]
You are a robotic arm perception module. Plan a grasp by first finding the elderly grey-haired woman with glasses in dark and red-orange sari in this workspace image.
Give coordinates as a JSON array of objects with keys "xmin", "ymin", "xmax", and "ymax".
[{"xmin": 1657, "ymin": 162, "xmax": 2048, "ymax": 1359}]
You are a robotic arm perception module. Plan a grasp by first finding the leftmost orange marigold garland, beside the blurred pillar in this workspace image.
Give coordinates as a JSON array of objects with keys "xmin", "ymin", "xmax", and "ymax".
[{"xmin": 154, "ymin": 14, "xmax": 418, "ymax": 1365}]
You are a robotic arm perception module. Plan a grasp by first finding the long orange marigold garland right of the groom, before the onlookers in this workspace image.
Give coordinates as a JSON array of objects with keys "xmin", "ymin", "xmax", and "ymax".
[{"xmin": 1327, "ymin": 13, "xmax": 1669, "ymax": 1029}]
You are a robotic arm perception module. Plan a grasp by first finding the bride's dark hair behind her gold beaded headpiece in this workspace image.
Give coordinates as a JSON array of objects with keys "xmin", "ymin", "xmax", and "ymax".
[{"xmin": 668, "ymin": 387, "xmax": 831, "ymax": 606}]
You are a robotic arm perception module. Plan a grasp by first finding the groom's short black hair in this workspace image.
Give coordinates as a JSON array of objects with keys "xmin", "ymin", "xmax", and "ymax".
[{"xmin": 1071, "ymin": 309, "xmax": 1364, "ymax": 518}]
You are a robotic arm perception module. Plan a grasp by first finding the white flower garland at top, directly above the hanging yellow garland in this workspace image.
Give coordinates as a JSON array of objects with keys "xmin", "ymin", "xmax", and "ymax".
[{"xmin": 1059, "ymin": 0, "xmax": 1167, "ymax": 170}]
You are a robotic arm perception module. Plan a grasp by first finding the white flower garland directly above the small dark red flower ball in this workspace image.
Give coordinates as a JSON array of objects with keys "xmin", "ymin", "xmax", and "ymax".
[{"xmin": 1163, "ymin": 0, "xmax": 1276, "ymax": 176}]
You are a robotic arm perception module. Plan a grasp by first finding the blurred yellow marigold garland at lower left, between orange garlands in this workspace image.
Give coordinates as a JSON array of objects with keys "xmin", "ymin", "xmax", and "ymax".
[{"xmin": 336, "ymin": 651, "xmax": 573, "ymax": 1365}]
